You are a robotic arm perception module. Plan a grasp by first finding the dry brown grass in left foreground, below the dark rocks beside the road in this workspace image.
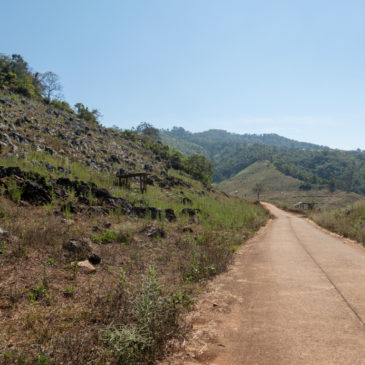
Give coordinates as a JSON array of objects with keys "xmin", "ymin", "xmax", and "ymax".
[{"xmin": 0, "ymin": 189, "xmax": 268, "ymax": 364}]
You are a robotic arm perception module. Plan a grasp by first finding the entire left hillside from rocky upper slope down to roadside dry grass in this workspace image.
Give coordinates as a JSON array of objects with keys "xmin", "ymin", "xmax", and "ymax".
[{"xmin": 0, "ymin": 91, "xmax": 267, "ymax": 364}]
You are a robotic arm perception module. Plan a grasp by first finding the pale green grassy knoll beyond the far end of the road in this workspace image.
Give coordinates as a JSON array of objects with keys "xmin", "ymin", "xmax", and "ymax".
[{"xmin": 219, "ymin": 162, "xmax": 364, "ymax": 209}]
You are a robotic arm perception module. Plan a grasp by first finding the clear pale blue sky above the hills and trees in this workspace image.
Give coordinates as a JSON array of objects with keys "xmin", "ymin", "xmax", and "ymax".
[{"xmin": 0, "ymin": 0, "xmax": 365, "ymax": 149}]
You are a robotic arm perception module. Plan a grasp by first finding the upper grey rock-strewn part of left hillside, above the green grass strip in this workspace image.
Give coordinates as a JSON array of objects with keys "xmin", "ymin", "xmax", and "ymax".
[{"xmin": 0, "ymin": 94, "xmax": 171, "ymax": 180}]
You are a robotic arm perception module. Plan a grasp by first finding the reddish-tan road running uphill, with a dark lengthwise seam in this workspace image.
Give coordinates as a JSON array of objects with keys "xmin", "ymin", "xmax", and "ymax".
[{"xmin": 162, "ymin": 204, "xmax": 365, "ymax": 365}]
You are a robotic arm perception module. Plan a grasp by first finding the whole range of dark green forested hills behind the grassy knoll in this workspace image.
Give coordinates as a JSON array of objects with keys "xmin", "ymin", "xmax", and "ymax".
[{"xmin": 160, "ymin": 127, "xmax": 365, "ymax": 194}]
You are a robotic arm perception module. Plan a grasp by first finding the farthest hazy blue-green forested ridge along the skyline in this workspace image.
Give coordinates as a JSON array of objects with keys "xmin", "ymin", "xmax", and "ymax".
[{"xmin": 160, "ymin": 127, "xmax": 326, "ymax": 160}]
